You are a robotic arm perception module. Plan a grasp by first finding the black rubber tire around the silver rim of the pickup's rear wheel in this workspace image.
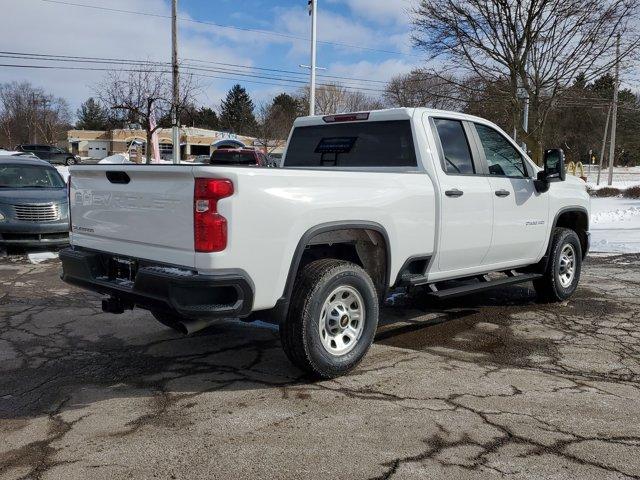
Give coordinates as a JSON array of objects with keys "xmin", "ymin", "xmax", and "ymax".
[{"xmin": 280, "ymin": 259, "xmax": 379, "ymax": 378}]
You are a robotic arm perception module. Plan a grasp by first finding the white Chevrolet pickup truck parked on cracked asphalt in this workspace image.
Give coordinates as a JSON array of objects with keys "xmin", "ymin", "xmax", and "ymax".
[{"xmin": 61, "ymin": 109, "xmax": 590, "ymax": 378}]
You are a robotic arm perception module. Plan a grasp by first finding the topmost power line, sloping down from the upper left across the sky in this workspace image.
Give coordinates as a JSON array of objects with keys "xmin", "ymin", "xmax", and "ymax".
[{"xmin": 40, "ymin": 0, "xmax": 412, "ymax": 57}]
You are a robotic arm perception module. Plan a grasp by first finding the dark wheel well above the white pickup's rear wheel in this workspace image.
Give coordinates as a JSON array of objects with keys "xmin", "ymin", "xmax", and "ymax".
[{"xmin": 298, "ymin": 228, "xmax": 389, "ymax": 295}]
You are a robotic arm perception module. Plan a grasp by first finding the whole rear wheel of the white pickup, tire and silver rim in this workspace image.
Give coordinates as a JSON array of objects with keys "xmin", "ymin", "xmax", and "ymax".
[{"xmin": 280, "ymin": 259, "xmax": 379, "ymax": 378}]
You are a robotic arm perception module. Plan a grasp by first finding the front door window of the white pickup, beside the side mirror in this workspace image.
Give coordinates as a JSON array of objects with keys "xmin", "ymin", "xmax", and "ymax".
[{"xmin": 475, "ymin": 123, "xmax": 527, "ymax": 178}]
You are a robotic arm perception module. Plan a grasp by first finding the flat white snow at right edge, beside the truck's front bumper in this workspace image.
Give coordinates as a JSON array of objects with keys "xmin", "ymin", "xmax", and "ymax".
[{"xmin": 591, "ymin": 198, "xmax": 640, "ymax": 253}]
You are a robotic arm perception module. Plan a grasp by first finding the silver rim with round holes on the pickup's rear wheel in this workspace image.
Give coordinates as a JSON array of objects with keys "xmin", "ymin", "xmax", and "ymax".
[{"xmin": 318, "ymin": 285, "xmax": 365, "ymax": 357}]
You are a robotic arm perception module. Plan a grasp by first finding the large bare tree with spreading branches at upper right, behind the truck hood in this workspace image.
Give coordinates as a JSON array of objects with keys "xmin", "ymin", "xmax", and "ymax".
[{"xmin": 414, "ymin": 0, "xmax": 640, "ymax": 161}]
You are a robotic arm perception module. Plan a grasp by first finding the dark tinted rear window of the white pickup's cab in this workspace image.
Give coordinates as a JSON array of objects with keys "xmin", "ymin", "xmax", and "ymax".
[{"xmin": 285, "ymin": 120, "xmax": 418, "ymax": 168}]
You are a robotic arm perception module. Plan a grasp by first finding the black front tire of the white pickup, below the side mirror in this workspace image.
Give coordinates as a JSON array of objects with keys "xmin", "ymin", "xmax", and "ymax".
[{"xmin": 533, "ymin": 228, "xmax": 582, "ymax": 302}]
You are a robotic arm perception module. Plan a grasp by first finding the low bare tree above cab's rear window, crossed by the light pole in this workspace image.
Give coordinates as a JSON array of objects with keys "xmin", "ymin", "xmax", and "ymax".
[{"xmin": 299, "ymin": 83, "xmax": 384, "ymax": 115}]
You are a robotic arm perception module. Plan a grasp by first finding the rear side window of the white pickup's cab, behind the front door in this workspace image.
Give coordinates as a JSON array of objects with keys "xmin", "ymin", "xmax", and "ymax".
[{"xmin": 433, "ymin": 118, "xmax": 476, "ymax": 175}]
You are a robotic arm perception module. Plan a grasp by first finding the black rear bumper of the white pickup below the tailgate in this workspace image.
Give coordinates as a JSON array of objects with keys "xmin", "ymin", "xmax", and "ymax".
[{"xmin": 60, "ymin": 248, "xmax": 254, "ymax": 318}]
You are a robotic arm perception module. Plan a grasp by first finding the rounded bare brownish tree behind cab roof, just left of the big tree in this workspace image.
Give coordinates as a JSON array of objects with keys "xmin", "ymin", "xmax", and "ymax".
[{"xmin": 384, "ymin": 70, "xmax": 464, "ymax": 110}]
